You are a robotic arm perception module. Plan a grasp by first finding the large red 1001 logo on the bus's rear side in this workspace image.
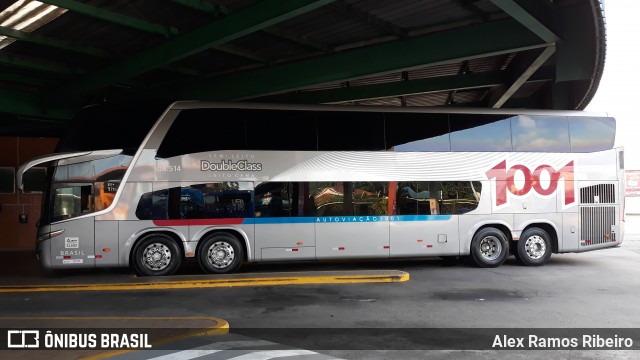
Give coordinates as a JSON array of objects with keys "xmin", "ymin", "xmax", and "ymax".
[{"xmin": 485, "ymin": 160, "xmax": 576, "ymax": 206}]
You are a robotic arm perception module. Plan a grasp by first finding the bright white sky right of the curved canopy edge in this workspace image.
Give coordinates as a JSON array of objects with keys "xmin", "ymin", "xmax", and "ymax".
[{"xmin": 585, "ymin": 0, "xmax": 640, "ymax": 170}]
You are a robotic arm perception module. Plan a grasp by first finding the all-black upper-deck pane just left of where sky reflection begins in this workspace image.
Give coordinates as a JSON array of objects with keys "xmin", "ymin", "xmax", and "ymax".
[{"xmin": 316, "ymin": 111, "xmax": 385, "ymax": 151}]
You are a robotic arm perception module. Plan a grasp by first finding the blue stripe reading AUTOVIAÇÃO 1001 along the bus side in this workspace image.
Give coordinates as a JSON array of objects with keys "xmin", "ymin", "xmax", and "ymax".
[{"xmin": 251, "ymin": 215, "xmax": 451, "ymax": 225}]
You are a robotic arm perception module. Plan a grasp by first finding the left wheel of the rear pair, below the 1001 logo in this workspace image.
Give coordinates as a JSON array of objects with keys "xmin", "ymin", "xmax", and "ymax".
[{"xmin": 471, "ymin": 227, "xmax": 509, "ymax": 268}]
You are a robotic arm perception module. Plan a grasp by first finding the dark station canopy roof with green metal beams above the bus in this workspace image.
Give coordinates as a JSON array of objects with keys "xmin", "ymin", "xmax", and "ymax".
[{"xmin": 0, "ymin": 0, "xmax": 605, "ymax": 136}]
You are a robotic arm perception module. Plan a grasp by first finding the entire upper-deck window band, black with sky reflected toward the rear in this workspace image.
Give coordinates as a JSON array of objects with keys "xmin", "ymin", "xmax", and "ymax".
[{"xmin": 157, "ymin": 107, "xmax": 615, "ymax": 158}]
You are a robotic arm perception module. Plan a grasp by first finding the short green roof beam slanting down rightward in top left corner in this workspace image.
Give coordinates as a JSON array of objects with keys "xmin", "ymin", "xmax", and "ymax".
[{"xmin": 39, "ymin": 0, "xmax": 178, "ymax": 36}]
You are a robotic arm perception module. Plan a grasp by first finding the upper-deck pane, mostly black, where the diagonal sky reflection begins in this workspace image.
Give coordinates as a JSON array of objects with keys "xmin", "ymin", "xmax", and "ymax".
[{"xmin": 385, "ymin": 113, "xmax": 450, "ymax": 151}]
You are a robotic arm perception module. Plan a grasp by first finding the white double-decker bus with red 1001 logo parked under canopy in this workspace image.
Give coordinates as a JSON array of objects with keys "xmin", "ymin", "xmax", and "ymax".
[{"xmin": 18, "ymin": 101, "xmax": 624, "ymax": 275}]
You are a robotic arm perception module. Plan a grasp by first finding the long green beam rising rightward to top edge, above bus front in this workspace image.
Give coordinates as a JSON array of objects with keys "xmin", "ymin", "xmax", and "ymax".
[{"xmin": 56, "ymin": 0, "xmax": 333, "ymax": 95}]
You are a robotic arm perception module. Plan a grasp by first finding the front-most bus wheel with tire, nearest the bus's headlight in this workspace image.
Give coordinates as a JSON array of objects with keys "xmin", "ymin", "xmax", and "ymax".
[{"xmin": 133, "ymin": 234, "xmax": 182, "ymax": 276}]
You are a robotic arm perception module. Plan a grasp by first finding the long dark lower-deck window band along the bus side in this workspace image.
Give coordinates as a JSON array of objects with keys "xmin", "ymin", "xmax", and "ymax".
[{"xmin": 136, "ymin": 181, "xmax": 482, "ymax": 220}]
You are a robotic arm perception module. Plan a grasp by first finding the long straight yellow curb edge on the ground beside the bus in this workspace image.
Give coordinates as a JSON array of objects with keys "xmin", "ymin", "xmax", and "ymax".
[{"xmin": 0, "ymin": 271, "xmax": 409, "ymax": 293}]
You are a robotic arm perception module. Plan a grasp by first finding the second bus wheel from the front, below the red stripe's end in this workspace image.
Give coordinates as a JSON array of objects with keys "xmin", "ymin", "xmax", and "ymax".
[{"xmin": 198, "ymin": 233, "xmax": 244, "ymax": 274}]
